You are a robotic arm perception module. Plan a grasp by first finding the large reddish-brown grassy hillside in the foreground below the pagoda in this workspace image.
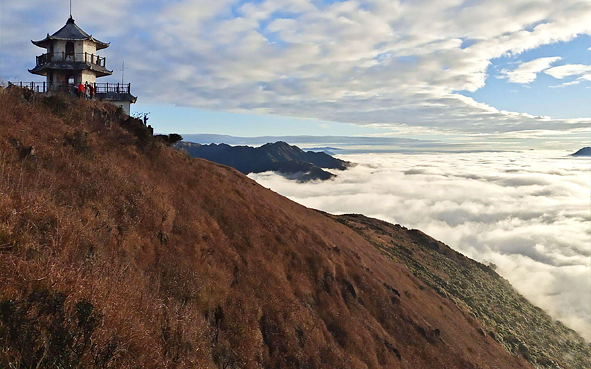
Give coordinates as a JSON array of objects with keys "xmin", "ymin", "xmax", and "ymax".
[{"xmin": 0, "ymin": 89, "xmax": 552, "ymax": 369}]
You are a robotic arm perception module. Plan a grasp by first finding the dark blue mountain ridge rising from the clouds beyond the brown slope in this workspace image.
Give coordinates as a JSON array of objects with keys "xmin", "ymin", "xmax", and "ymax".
[{"xmin": 176, "ymin": 141, "xmax": 351, "ymax": 182}]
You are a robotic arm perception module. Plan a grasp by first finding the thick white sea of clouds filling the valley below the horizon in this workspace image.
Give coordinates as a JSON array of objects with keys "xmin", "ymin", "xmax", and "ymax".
[{"xmin": 249, "ymin": 151, "xmax": 591, "ymax": 340}]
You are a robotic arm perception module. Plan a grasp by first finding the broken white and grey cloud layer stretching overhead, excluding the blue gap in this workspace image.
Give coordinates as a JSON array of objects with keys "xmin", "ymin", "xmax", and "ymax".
[{"xmin": 0, "ymin": 0, "xmax": 591, "ymax": 138}]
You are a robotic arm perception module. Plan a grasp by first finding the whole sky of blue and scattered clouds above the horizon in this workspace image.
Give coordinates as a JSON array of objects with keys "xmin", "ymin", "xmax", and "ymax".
[{"xmin": 0, "ymin": 0, "xmax": 591, "ymax": 149}]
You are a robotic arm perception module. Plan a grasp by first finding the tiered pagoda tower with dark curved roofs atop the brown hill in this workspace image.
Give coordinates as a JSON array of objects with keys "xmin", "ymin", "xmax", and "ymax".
[{"xmin": 29, "ymin": 15, "xmax": 137, "ymax": 114}]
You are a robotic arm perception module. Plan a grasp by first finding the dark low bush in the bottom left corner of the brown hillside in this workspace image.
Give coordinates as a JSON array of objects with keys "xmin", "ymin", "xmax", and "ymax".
[{"xmin": 0, "ymin": 290, "xmax": 117, "ymax": 368}]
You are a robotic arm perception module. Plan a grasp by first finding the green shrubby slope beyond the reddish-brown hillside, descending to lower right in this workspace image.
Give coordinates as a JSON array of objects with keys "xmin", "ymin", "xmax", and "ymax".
[{"xmin": 336, "ymin": 215, "xmax": 591, "ymax": 368}]
